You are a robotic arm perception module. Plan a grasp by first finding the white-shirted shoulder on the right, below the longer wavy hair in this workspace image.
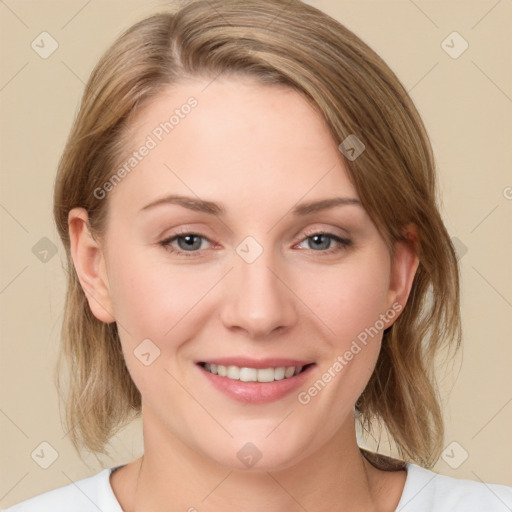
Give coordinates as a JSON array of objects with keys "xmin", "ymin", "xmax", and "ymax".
[{"xmin": 396, "ymin": 463, "xmax": 512, "ymax": 512}]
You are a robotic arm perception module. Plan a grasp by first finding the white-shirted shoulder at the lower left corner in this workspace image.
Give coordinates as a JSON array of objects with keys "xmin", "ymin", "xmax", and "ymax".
[{"xmin": 4, "ymin": 468, "xmax": 123, "ymax": 512}]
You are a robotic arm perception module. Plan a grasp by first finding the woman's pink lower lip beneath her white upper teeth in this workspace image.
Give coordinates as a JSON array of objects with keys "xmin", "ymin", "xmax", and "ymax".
[{"xmin": 198, "ymin": 364, "xmax": 315, "ymax": 404}]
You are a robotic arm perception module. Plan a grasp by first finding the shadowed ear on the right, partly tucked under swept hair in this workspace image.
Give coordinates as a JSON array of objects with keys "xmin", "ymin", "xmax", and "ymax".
[{"xmin": 387, "ymin": 224, "xmax": 419, "ymax": 327}]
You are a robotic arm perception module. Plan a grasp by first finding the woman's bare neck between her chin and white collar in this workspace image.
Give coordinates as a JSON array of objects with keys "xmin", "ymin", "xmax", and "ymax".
[{"xmin": 127, "ymin": 411, "xmax": 396, "ymax": 512}]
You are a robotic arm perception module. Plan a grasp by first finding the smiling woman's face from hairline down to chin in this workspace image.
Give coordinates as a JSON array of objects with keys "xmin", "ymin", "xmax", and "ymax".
[{"xmin": 74, "ymin": 78, "xmax": 415, "ymax": 469}]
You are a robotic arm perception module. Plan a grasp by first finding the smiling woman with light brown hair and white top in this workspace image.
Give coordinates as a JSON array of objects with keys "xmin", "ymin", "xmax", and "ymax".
[{"xmin": 5, "ymin": 0, "xmax": 512, "ymax": 512}]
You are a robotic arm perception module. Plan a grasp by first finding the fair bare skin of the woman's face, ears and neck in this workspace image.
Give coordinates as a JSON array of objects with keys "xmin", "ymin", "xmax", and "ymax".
[{"xmin": 69, "ymin": 77, "xmax": 418, "ymax": 512}]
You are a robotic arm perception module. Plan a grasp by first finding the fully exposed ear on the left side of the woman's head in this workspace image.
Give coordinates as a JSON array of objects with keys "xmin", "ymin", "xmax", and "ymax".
[{"xmin": 68, "ymin": 208, "xmax": 115, "ymax": 323}]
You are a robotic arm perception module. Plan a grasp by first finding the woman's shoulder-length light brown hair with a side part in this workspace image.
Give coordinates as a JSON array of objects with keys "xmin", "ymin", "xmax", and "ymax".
[{"xmin": 54, "ymin": 0, "xmax": 461, "ymax": 467}]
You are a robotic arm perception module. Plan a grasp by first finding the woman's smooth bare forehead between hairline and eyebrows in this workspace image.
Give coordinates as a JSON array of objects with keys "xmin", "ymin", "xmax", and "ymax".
[{"xmin": 106, "ymin": 77, "xmax": 357, "ymax": 216}]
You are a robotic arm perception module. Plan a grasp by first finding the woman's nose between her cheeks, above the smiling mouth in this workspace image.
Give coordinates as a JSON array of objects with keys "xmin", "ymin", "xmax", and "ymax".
[{"xmin": 221, "ymin": 244, "xmax": 298, "ymax": 339}]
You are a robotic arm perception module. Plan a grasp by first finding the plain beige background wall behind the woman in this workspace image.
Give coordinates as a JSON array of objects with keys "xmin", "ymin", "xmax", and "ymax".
[{"xmin": 0, "ymin": 0, "xmax": 512, "ymax": 507}]
